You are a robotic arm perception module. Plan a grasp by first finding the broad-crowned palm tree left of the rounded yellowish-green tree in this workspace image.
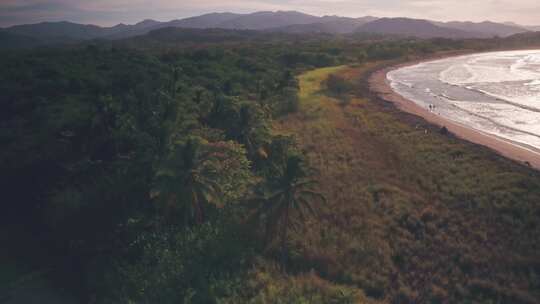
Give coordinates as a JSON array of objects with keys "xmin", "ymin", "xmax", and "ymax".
[{"xmin": 153, "ymin": 138, "xmax": 222, "ymax": 224}]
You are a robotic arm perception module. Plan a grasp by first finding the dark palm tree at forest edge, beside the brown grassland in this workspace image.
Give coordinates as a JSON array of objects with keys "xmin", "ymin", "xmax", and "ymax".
[{"xmin": 254, "ymin": 155, "xmax": 326, "ymax": 264}]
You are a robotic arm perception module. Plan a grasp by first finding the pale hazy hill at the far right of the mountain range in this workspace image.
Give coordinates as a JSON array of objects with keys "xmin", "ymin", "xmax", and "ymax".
[{"xmin": 435, "ymin": 21, "xmax": 527, "ymax": 38}]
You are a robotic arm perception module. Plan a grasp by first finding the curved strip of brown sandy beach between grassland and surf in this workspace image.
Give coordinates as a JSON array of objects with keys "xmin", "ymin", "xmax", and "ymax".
[{"xmin": 368, "ymin": 52, "xmax": 540, "ymax": 170}]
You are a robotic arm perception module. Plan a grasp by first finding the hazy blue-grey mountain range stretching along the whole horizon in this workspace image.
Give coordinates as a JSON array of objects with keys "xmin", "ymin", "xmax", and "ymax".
[{"xmin": 0, "ymin": 11, "xmax": 540, "ymax": 48}]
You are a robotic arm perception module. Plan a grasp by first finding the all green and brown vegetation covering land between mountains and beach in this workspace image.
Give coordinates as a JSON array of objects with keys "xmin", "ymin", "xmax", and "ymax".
[{"xmin": 0, "ymin": 29, "xmax": 540, "ymax": 303}]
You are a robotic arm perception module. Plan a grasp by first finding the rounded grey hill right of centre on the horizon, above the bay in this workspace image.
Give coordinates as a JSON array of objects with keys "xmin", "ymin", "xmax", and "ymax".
[{"xmin": 357, "ymin": 18, "xmax": 477, "ymax": 38}]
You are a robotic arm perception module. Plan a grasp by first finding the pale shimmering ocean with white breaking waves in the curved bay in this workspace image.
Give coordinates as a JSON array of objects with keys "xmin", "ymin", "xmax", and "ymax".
[{"xmin": 387, "ymin": 50, "xmax": 540, "ymax": 152}]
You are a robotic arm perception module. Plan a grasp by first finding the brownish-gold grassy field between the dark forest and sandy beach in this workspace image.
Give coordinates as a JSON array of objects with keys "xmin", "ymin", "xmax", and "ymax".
[{"xmin": 274, "ymin": 63, "xmax": 540, "ymax": 303}]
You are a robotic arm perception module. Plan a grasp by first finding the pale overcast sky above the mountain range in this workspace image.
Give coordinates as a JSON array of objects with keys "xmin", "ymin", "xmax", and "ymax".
[{"xmin": 0, "ymin": 0, "xmax": 540, "ymax": 27}]
